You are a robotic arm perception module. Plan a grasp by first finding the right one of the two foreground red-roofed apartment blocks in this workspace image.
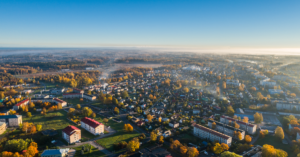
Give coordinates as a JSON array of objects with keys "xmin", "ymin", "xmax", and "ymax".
[{"xmin": 80, "ymin": 117, "xmax": 104, "ymax": 135}]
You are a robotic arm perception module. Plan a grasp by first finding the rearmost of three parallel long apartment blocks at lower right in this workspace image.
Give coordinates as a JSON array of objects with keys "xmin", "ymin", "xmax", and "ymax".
[{"xmin": 220, "ymin": 115, "xmax": 257, "ymax": 135}]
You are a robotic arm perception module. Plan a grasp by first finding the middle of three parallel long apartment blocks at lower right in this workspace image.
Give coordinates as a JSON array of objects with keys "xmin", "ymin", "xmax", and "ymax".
[{"xmin": 208, "ymin": 120, "xmax": 245, "ymax": 140}]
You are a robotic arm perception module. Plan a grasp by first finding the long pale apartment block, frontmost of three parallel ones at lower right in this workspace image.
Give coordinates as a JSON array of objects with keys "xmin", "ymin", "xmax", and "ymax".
[{"xmin": 193, "ymin": 124, "xmax": 232, "ymax": 147}]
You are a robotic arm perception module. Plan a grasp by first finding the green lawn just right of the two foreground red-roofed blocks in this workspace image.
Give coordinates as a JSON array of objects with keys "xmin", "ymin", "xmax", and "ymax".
[{"xmin": 96, "ymin": 131, "xmax": 140, "ymax": 151}]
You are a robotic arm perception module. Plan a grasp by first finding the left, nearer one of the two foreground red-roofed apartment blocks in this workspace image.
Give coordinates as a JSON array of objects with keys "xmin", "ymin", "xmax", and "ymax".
[{"xmin": 62, "ymin": 125, "xmax": 81, "ymax": 144}]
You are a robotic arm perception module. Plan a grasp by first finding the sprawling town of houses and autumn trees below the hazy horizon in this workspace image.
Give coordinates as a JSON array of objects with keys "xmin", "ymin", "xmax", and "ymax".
[{"xmin": 0, "ymin": 51, "xmax": 300, "ymax": 157}]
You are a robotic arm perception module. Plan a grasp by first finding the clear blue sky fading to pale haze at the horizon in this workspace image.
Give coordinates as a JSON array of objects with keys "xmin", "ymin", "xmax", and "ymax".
[{"xmin": 0, "ymin": 0, "xmax": 300, "ymax": 48}]
